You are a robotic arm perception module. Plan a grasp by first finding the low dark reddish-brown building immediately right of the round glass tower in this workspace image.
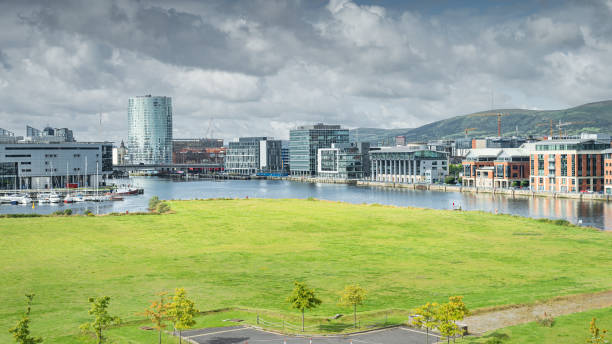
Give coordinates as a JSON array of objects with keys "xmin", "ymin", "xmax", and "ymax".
[{"xmin": 172, "ymin": 139, "xmax": 223, "ymax": 164}]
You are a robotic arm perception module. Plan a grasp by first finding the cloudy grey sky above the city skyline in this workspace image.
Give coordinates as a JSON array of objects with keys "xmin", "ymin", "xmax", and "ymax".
[{"xmin": 0, "ymin": 0, "xmax": 612, "ymax": 142}]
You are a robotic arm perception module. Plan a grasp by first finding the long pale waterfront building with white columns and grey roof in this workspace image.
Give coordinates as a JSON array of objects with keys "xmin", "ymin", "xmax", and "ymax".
[{"xmin": 370, "ymin": 147, "xmax": 448, "ymax": 183}]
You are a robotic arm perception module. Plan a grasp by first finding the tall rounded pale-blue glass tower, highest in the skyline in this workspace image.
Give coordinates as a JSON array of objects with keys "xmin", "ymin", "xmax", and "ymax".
[{"xmin": 128, "ymin": 94, "xmax": 172, "ymax": 165}]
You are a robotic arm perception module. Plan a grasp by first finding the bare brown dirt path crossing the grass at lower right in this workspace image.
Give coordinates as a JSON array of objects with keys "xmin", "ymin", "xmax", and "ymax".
[{"xmin": 462, "ymin": 290, "xmax": 612, "ymax": 333}]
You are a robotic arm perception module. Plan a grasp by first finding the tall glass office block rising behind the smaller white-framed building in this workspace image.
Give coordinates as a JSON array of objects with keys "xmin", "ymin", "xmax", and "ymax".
[{"xmin": 289, "ymin": 123, "xmax": 349, "ymax": 176}]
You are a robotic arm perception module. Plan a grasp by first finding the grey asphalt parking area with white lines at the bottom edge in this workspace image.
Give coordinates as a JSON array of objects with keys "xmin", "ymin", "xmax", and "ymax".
[{"xmin": 183, "ymin": 326, "xmax": 437, "ymax": 344}]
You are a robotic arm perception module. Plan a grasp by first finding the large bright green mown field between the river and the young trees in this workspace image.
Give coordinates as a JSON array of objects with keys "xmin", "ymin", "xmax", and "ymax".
[{"xmin": 0, "ymin": 199, "xmax": 612, "ymax": 343}]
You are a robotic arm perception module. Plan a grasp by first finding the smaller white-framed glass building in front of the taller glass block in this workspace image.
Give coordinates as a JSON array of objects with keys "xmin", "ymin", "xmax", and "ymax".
[{"xmin": 317, "ymin": 143, "xmax": 363, "ymax": 180}]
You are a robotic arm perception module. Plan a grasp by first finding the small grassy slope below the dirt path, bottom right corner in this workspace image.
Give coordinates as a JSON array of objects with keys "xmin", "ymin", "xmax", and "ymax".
[{"xmin": 460, "ymin": 308, "xmax": 612, "ymax": 344}]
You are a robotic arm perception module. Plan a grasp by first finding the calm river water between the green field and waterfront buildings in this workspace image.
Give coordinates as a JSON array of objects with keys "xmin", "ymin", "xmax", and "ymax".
[{"xmin": 0, "ymin": 177, "xmax": 612, "ymax": 230}]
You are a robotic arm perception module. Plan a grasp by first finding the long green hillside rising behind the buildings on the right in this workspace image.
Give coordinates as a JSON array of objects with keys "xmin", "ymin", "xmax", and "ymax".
[{"xmin": 356, "ymin": 100, "xmax": 612, "ymax": 141}]
